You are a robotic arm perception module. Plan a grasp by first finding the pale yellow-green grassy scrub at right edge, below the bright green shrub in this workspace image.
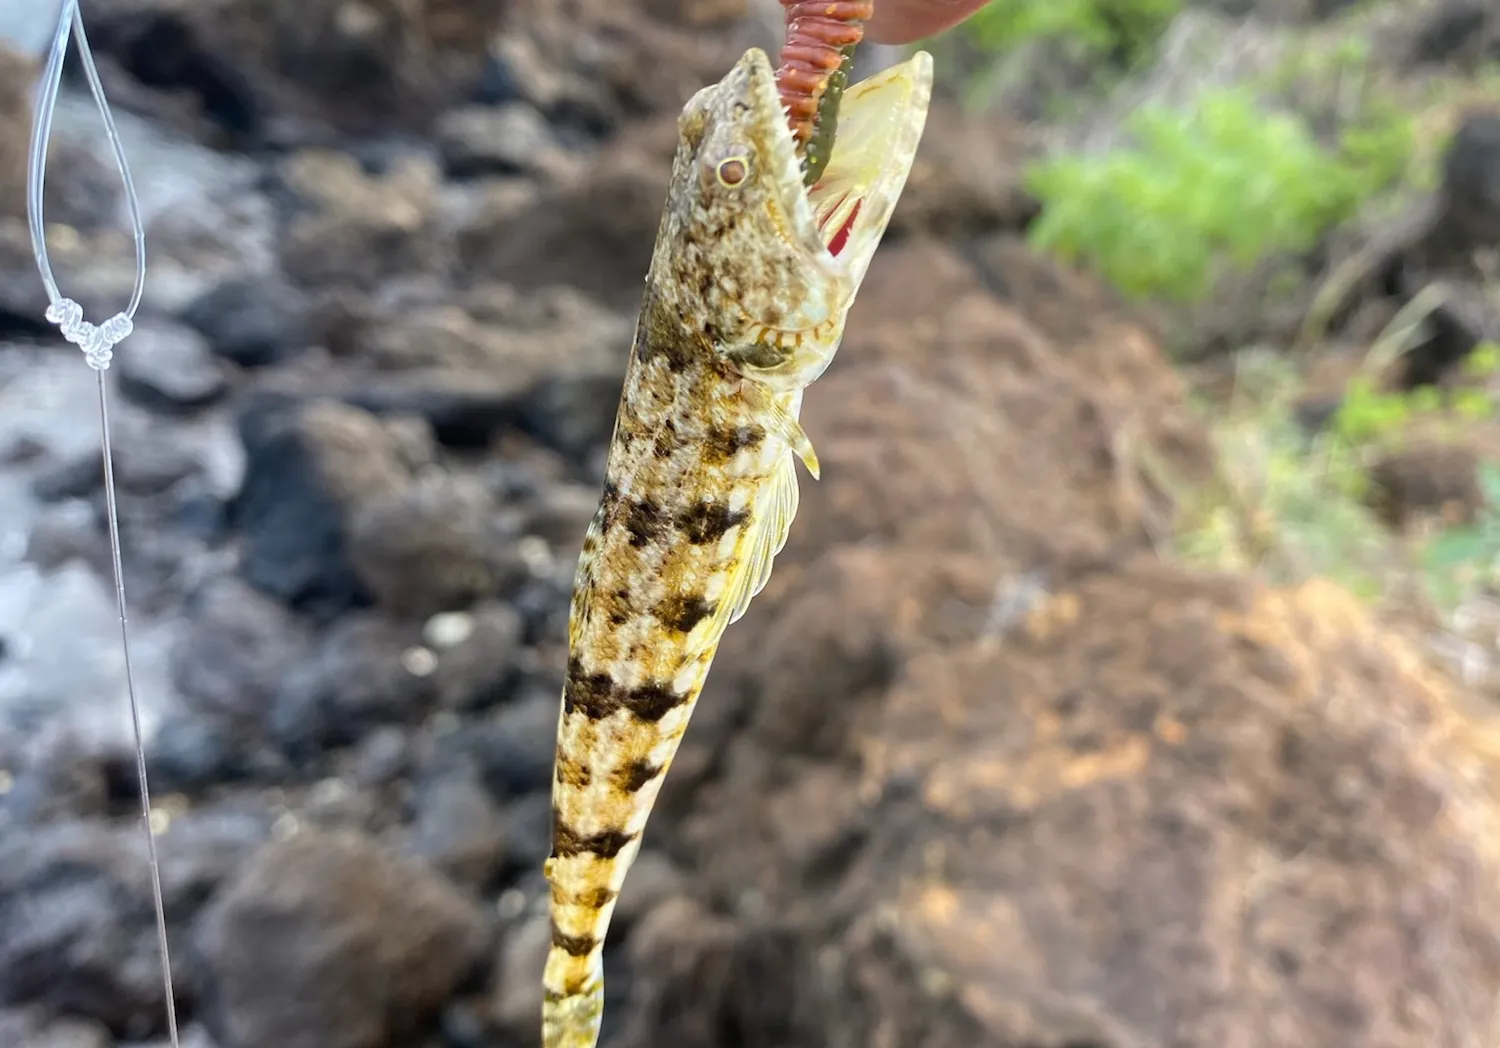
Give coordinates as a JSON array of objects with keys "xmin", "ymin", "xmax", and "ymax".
[{"xmin": 1175, "ymin": 343, "xmax": 1500, "ymax": 615}]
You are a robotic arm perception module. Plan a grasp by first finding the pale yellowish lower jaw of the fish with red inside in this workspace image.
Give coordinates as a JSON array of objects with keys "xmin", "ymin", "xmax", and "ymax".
[{"xmin": 807, "ymin": 51, "xmax": 933, "ymax": 286}]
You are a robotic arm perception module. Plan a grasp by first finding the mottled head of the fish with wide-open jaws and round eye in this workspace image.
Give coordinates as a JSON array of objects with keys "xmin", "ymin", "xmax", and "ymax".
[{"xmin": 651, "ymin": 48, "xmax": 932, "ymax": 390}]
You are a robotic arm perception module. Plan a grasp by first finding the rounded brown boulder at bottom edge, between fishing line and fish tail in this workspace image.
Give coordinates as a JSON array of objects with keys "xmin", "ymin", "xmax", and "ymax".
[{"xmin": 197, "ymin": 831, "xmax": 489, "ymax": 1048}]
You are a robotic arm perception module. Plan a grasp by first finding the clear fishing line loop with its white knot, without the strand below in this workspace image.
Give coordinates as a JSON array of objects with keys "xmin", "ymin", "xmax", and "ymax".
[{"xmin": 26, "ymin": 0, "xmax": 146, "ymax": 372}]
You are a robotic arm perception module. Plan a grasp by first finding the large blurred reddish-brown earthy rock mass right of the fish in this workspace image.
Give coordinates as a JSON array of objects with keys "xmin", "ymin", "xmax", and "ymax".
[{"xmin": 617, "ymin": 243, "xmax": 1500, "ymax": 1048}]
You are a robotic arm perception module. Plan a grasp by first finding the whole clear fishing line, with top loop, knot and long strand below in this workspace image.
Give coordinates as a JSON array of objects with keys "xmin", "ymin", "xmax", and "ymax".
[{"xmin": 26, "ymin": 0, "xmax": 180, "ymax": 1048}]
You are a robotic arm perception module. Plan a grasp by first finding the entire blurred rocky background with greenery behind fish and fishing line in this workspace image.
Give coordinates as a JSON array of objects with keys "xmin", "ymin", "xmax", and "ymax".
[{"xmin": 0, "ymin": 0, "xmax": 1500, "ymax": 1048}]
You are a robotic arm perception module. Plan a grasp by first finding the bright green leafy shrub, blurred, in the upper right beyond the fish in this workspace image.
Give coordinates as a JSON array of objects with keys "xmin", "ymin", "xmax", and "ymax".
[{"xmin": 1028, "ymin": 88, "xmax": 1410, "ymax": 303}]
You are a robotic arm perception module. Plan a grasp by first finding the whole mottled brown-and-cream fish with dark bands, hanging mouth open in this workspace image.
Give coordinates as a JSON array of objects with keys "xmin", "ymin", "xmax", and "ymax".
[{"xmin": 543, "ymin": 49, "xmax": 932, "ymax": 1048}]
